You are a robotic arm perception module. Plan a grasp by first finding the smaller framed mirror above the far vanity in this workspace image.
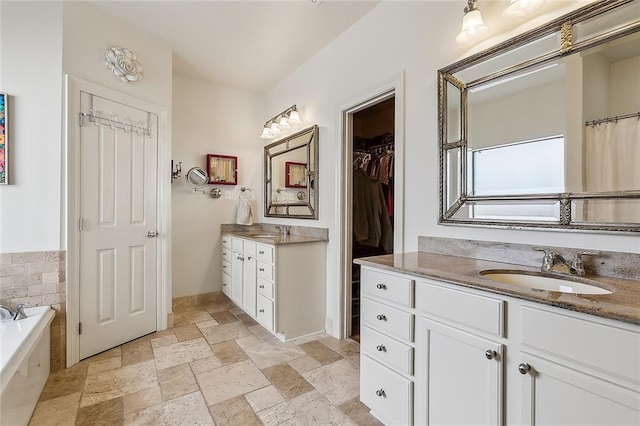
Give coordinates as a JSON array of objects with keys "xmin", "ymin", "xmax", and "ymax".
[{"xmin": 264, "ymin": 126, "xmax": 318, "ymax": 219}]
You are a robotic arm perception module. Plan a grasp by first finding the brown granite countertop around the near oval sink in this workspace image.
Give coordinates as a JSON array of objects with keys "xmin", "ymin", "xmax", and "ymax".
[{"xmin": 354, "ymin": 252, "xmax": 640, "ymax": 325}]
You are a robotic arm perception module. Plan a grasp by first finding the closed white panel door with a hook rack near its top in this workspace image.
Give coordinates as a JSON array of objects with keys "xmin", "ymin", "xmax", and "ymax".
[{"xmin": 78, "ymin": 92, "xmax": 158, "ymax": 359}]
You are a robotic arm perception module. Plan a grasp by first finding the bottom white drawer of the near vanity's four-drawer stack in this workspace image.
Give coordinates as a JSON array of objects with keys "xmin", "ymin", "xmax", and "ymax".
[{"xmin": 360, "ymin": 354, "xmax": 413, "ymax": 425}]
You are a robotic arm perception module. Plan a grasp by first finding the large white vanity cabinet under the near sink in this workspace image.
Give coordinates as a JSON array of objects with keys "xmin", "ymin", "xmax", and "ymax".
[{"xmin": 361, "ymin": 266, "xmax": 640, "ymax": 425}]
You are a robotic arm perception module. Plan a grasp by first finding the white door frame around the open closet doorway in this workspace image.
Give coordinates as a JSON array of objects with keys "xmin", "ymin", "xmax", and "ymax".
[{"xmin": 336, "ymin": 72, "xmax": 405, "ymax": 339}]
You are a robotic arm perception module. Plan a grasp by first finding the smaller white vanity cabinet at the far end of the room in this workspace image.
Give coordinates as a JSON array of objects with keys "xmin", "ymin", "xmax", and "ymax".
[{"xmin": 222, "ymin": 235, "xmax": 326, "ymax": 341}]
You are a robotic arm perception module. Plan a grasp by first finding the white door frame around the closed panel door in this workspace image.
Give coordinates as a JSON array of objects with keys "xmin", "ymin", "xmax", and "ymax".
[{"xmin": 63, "ymin": 74, "xmax": 171, "ymax": 367}]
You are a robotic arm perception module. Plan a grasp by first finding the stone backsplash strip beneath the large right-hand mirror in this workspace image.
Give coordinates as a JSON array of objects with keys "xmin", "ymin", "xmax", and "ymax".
[{"xmin": 418, "ymin": 237, "xmax": 640, "ymax": 281}]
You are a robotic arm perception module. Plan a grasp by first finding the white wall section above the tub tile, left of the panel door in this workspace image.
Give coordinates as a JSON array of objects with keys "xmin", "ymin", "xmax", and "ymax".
[{"xmin": 0, "ymin": 2, "xmax": 63, "ymax": 253}]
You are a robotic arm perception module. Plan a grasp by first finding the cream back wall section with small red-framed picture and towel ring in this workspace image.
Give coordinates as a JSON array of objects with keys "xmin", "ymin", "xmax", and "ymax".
[{"xmin": 171, "ymin": 76, "xmax": 265, "ymax": 298}]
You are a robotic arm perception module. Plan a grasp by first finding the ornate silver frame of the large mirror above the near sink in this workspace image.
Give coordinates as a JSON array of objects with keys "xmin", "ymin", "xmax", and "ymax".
[{"xmin": 438, "ymin": 0, "xmax": 640, "ymax": 233}]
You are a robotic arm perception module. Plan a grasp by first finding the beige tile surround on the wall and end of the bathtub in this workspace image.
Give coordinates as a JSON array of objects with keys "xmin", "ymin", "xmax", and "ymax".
[{"xmin": 0, "ymin": 250, "xmax": 67, "ymax": 371}]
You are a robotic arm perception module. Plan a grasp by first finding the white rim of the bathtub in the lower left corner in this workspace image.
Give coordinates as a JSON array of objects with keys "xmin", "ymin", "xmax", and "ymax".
[{"xmin": 0, "ymin": 306, "xmax": 55, "ymax": 394}]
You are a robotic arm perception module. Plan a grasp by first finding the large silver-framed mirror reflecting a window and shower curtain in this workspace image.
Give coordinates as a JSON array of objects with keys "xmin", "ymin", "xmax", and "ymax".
[{"xmin": 438, "ymin": 0, "xmax": 640, "ymax": 232}]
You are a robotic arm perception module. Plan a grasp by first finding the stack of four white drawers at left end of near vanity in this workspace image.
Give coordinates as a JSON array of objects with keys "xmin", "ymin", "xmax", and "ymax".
[{"xmin": 360, "ymin": 267, "xmax": 415, "ymax": 425}]
